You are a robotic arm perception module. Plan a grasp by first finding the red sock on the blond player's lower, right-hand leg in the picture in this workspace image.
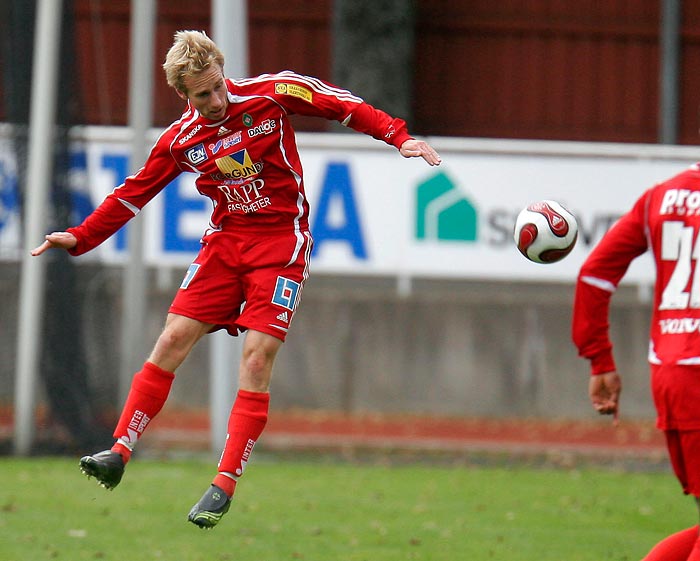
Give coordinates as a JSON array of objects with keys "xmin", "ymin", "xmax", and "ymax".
[{"xmin": 213, "ymin": 390, "xmax": 270, "ymax": 497}]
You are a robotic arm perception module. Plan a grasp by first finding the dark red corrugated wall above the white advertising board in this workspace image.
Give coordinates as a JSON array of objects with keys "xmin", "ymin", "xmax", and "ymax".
[{"xmin": 5, "ymin": 0, "xmax": 700, "ymax": 144}]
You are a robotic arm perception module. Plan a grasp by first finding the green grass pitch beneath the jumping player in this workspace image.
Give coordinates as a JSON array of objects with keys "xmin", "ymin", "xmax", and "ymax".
[{"xmin": 0, "ymin": 457, "xmax": 697, "ymax": 561}]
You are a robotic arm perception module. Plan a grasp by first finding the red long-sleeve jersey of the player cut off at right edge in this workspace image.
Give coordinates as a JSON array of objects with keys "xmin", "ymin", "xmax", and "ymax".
[{"xmin": 572, "ymin": 164, "xmax": 700, "ymax": 374}]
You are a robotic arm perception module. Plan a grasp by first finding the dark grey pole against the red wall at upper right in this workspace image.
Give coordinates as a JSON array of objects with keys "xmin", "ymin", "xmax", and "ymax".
[{"xmin": 659, "ymin": 0, "xmax": 682, "ymax": 144}]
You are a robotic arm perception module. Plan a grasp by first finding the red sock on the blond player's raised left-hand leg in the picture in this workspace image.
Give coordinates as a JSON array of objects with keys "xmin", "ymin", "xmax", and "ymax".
[{"xmin": 112, "ymin": 362, "xmax": 175, "ymax": 463}]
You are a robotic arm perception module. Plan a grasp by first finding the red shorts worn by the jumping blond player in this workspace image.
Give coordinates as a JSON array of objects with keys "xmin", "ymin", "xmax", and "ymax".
[{"xmin": 169, "ymin": 231, "xmax": 313, "ymax": 341}]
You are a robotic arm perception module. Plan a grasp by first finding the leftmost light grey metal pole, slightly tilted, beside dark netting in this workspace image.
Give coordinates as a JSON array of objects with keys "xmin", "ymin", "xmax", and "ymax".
[{"xmin": 14, "ymin": 0, "xmax": 63, "ymax": 455}]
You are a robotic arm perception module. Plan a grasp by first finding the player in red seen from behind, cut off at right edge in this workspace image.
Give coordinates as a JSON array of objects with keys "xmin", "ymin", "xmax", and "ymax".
[{"xmin": 572, "ymin": 164, "xmax": 700, "ymax": 561}]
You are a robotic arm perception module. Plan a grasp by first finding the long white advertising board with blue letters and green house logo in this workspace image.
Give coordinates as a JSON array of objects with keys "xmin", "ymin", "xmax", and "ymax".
[{"xmin": 0, "ymin": 127, "xmax": 695, "ymax": 283}]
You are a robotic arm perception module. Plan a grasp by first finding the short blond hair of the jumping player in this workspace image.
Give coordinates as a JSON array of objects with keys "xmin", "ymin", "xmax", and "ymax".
[{"xmin": 163, "ymin": 30, "xmax": 224, "ymax": 93}]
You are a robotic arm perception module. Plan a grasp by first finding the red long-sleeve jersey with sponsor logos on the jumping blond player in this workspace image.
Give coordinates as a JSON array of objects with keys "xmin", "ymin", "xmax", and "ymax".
[{"xmin": 68, "ymin": 71, "xmax": 411, "ymax": 255}]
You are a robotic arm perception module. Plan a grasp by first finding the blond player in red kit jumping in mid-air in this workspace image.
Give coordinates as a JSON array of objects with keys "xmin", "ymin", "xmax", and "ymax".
[{"xmin": 32, "ymin": 31, "xmax": 441, "ymax": 528}]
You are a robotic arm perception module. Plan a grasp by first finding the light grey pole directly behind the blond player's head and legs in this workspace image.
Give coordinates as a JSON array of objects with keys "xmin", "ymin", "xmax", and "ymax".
[{"xmin": 209, "ymin": 0, "xmax": 248, "ymax": 453}]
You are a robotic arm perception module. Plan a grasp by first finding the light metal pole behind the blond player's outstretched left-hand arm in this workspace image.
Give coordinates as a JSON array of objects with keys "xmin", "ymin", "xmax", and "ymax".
[{"xmin": 119, "ymin": 0, "xmax": 156, "ymax": 402}]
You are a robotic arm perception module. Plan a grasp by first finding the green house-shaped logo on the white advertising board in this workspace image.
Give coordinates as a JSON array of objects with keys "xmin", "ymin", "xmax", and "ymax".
[{"xmin": 416, "ymin": 172, "xmax": 477, "ymax": 242}]
